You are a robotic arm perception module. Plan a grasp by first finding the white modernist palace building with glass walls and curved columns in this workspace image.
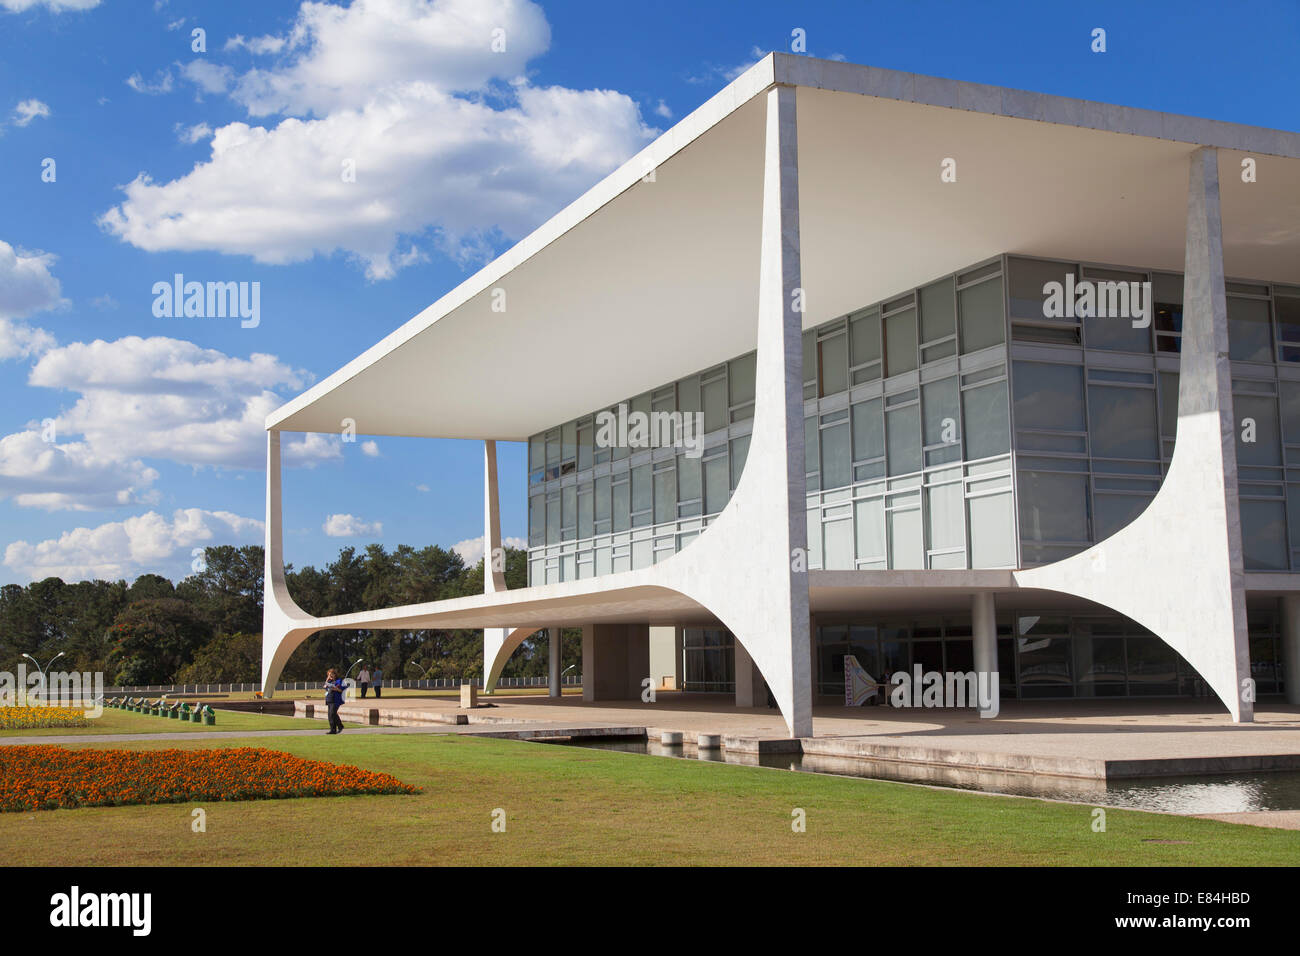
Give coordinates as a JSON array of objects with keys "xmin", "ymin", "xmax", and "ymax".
[{"xmin": 263, "ymin": 53, "xmax": 1300, "ymax": 736}]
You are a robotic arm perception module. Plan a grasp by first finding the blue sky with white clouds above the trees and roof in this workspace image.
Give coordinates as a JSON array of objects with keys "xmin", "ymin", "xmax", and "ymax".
[{"xmin": 0, "ymin": 0, "xmax": 1300, "ymax": 583}]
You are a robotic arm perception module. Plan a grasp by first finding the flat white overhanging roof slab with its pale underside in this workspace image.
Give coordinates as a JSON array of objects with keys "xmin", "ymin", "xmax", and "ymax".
[{"xmin": 267, "ymin": 53, "xmax": 1300, "ymax": 441}]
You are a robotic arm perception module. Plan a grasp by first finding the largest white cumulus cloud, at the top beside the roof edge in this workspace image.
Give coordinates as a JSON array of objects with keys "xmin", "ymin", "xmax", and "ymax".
[{"xmin": 100, "ymin": 0, "xmax": 657, "ymax": 278}]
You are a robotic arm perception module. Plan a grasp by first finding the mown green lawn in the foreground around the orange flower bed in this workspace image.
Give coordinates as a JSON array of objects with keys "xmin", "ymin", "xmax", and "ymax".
[{"xmin": 0, "ymin": 732, "xmax": 1300, "ymax": 866}]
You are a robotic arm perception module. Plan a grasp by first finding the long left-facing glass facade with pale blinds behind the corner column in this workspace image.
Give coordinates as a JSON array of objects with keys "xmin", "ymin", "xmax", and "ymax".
[{"xmin": 528, "ymin": 259, "xmax": 1017, "ymax": 584}]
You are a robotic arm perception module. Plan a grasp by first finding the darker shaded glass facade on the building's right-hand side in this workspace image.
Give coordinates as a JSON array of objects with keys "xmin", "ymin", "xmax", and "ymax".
[{"xmin": 1006, "ymin": 256, "xmax": 1300, "ymax": 571}]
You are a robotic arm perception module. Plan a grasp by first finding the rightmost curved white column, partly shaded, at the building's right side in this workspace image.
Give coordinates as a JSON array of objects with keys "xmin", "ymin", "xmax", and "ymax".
[{"xmin": 1015, "ymin": 148, "xmax": 1255, "ymax": 721}]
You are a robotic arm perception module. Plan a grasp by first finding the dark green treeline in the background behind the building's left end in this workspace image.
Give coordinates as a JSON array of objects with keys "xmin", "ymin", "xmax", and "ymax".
[{"xmin": 0, "ymin": 545, "xmax": 581, "ymax": 684}]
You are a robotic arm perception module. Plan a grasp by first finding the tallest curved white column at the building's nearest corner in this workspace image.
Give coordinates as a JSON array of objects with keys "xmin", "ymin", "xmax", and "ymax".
[{"xmin": 647, "ymin": 86, "xmax": 813, "ymax": 736}]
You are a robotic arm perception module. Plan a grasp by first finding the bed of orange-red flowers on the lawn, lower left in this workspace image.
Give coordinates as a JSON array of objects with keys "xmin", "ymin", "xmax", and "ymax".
[{"xmin": 0, "ymin": 747, "xmax": 420, "ymax": 813}]
